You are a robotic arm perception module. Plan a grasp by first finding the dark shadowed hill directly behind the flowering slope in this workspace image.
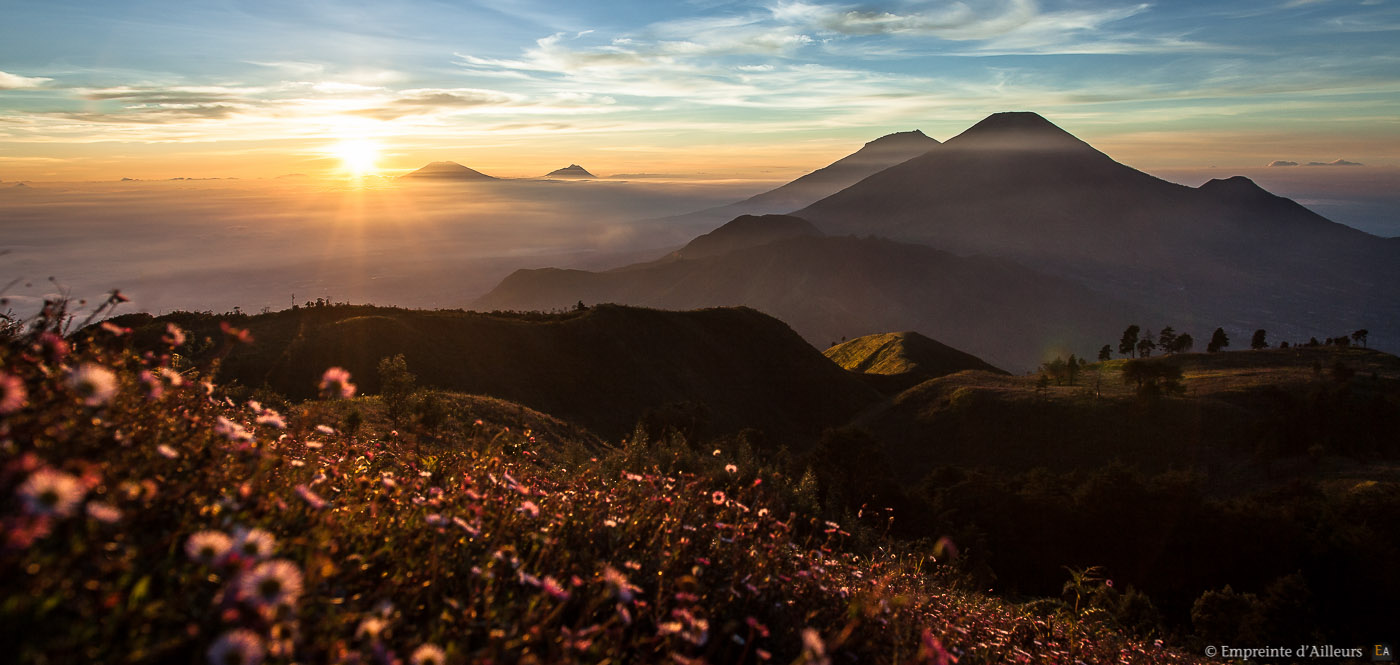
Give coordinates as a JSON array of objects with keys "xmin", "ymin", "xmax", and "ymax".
[{"xmin": 112, "ymin": 307, "xmax": 876, "ymax": 442}]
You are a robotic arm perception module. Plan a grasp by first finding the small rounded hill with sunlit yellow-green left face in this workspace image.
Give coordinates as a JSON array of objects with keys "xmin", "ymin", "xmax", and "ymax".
[{"xmin": 823, "ymin": 330, "xmax": 1007, "ymax": 393}]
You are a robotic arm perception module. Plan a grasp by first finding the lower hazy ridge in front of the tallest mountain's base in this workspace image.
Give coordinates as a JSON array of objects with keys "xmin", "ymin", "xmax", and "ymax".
[{"xmin": 473, "ymin": 232, "xmax": 1137, "ymax": 368}]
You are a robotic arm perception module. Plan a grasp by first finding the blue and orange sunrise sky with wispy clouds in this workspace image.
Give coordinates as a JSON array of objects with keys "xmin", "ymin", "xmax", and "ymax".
[{"xmin": 0, "ymin": 0, "xmax": 1400, "ymax": 182}]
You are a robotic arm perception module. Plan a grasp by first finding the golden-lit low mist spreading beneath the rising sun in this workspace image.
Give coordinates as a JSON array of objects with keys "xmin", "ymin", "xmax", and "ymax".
[{"xmin": 0, "ymin": 179, "xmax": 771, "ymax": 315}]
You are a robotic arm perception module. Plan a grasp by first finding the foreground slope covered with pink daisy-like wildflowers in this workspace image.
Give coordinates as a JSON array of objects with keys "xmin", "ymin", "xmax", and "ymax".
[{"xmin": 0, "ymin": 329, "xmax": 1193, "ymax": 664}]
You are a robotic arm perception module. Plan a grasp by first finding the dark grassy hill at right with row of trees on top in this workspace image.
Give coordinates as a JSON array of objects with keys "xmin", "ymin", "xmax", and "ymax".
[{"xmin": 860, "ymin": 349, "xmax": 1400, "ymax": 483}]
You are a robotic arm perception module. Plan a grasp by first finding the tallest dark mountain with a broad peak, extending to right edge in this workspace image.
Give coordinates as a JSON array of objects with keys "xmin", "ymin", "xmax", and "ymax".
[{"xmin": 794, "ymin": 112, "xmax": 1400, "ymax": 349}]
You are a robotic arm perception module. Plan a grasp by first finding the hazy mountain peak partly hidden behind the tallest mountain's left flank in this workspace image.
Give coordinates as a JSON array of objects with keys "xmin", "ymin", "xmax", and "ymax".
[{"xmin": 658, "ymin": 129, "xmax": 938, "ymax": 223}]
